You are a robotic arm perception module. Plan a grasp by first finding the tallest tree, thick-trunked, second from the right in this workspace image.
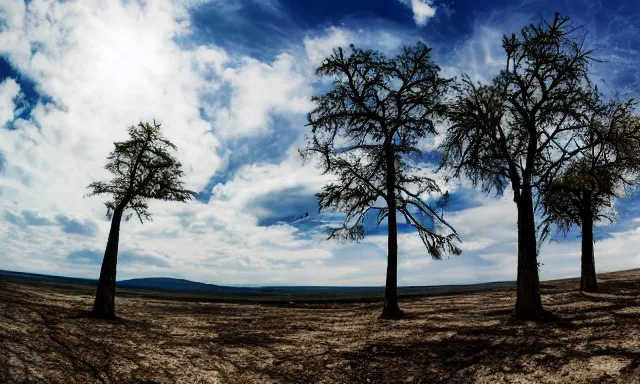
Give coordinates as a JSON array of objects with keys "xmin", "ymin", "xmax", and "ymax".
[{"xmin": 442, "ymin": 14, "xmax": 597, "ymax": 320}]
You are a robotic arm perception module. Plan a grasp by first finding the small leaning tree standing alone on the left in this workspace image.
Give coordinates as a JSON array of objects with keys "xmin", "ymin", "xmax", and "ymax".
[{"xmin": 88, "ymin": 121, "xmax": 196, "ymax": 318}]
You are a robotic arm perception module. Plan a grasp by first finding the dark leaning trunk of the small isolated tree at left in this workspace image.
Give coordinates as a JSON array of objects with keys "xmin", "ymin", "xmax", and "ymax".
[{"xmin": 91, "ymin": 206, "xmax": 124, "ymax": 319}]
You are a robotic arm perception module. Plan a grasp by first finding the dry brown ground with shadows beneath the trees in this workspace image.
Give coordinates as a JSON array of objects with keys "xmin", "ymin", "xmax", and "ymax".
[{"xmin": 0, "ymin": 270, "xmax": 640, "ymax": 384}]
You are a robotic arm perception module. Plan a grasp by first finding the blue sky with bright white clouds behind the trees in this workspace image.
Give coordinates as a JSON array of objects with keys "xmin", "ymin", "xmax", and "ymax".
[{"xmin": 0, "ymin": 0, "xmax": 640, "ymax": 285}]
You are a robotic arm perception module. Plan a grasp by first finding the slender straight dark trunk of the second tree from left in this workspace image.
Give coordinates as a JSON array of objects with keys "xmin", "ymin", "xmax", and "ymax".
[{"xmin": 380, "ymin": 149, "xmax": 402, "ymax": 319}]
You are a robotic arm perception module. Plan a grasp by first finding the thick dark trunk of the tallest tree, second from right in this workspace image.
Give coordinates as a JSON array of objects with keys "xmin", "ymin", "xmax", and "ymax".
[{"xmin": 515, "ymin": 187, "xmax": 543, "ymax": 321}]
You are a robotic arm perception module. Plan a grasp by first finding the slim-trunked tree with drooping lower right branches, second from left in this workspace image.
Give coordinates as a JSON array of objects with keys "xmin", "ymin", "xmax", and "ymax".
[{"xmin": 301, "ymin": 43, "xmax": 460, "ymax": 319}]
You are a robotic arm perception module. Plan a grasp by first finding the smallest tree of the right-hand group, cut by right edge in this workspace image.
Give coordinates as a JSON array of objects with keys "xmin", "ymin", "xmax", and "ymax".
[{"xmin": 542, "ymin": 101, "xmax": 640, "ymax": 292}]
